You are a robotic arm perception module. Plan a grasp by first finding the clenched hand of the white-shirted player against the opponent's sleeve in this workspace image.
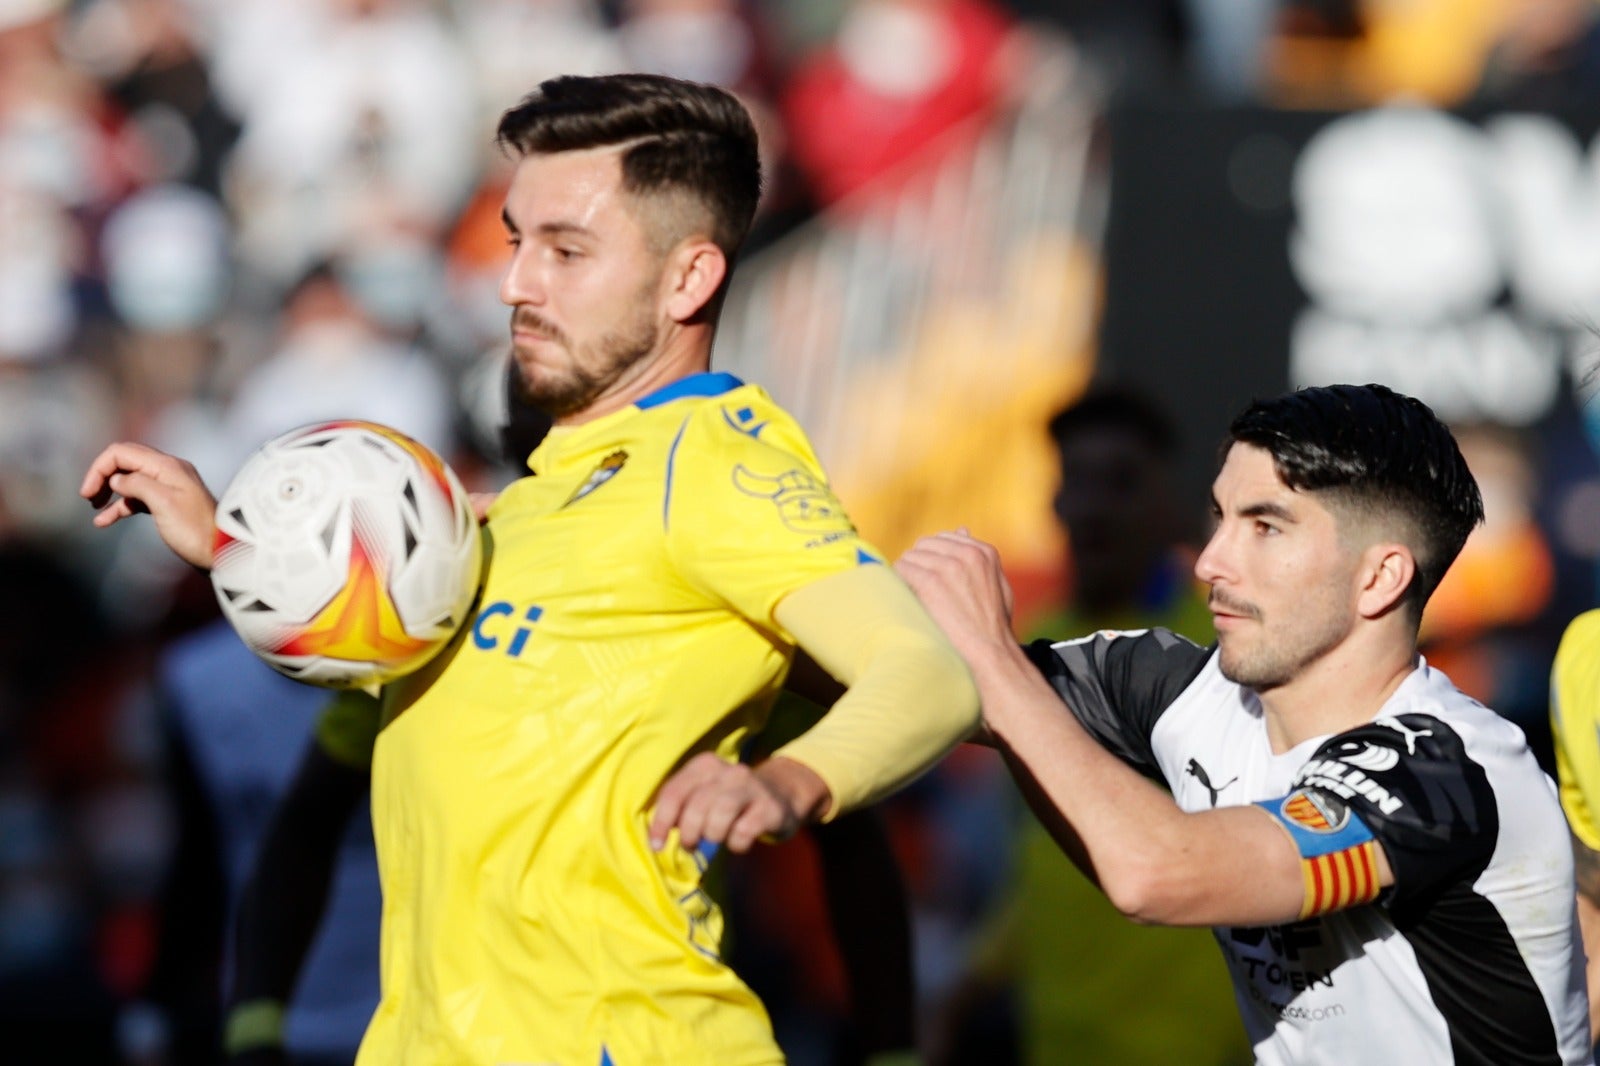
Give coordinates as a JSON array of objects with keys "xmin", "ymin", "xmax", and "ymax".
[{"xmin": 894, "ymin": 530, "xmax": 1016, "ymax": 664}]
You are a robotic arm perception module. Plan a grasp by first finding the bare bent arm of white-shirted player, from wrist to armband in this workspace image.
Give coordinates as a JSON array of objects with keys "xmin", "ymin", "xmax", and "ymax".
[{"xmin": 973, "ymin": 633, "xmax": 1304, "ymax": 925}]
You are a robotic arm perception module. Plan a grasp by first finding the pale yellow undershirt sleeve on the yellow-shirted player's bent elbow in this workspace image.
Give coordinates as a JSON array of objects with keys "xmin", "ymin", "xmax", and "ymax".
[{"xmin": 774, "ymin": 565, "xmax": 978, "ymax": 820}]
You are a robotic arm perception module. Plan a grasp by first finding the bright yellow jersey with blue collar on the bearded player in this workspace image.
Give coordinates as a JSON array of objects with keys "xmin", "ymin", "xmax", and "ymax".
[{"xmin": 357, "ymin": 373, "xmax": 882, "ymax": 1066}]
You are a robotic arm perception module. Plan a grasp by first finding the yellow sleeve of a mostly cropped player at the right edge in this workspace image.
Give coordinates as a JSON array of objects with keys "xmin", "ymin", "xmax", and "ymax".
[{"xmin": 1550, "ymin": 610, "xmax": 1600, "ymax": 852}]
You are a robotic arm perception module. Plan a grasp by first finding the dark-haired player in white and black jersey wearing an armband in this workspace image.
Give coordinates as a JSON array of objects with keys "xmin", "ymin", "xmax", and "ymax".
[{"xmin": 899, "ymin": 386, "xmax": 1592, "ymax": 1066}]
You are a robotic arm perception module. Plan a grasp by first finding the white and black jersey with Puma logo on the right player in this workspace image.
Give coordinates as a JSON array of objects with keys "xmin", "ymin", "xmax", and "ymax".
[{"xmin": 1027, "ymin": 629, "xmax": 1592, "ymax": 1066}]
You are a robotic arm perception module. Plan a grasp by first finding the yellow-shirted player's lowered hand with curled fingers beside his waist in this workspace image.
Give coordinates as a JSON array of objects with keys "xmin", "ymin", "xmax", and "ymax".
[{"xmin": 650, "ymin": 752, "xmax": 829, "ymax": 853}]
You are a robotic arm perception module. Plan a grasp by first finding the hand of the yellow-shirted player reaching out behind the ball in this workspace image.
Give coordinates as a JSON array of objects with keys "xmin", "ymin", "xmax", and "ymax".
[{"xmin": 78, "ymin": 442, "xmax": 216, "ymax": 570}]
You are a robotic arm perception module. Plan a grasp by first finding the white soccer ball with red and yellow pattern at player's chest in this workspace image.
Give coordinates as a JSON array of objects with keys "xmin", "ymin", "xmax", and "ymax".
[{"xmin": 211, "ymin": 421, "xmax": 483, "ymax": 688}]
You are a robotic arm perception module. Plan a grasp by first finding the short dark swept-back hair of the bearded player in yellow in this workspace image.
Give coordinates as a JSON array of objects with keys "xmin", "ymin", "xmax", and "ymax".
[{"xmin": 494, "ymin": 74, "xmax": 762, "ymax": 262}]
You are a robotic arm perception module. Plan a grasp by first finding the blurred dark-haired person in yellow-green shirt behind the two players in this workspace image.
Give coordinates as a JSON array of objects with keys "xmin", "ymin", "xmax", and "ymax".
[{"xmin": 950, "ymin": 391, "xmax": 1250, "ymax": 1066}]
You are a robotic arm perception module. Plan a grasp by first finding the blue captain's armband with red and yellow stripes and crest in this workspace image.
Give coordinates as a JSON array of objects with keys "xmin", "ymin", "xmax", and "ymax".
[{"xmin": 1256, "ymin": 789, "xmax": 1382, "ymax": 919}]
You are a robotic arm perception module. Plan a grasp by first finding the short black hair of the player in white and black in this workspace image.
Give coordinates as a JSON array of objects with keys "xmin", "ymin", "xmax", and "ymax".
[{"xmin": 1229, "ymin": 384, "xmax": 1483, "ymax": 618}]
